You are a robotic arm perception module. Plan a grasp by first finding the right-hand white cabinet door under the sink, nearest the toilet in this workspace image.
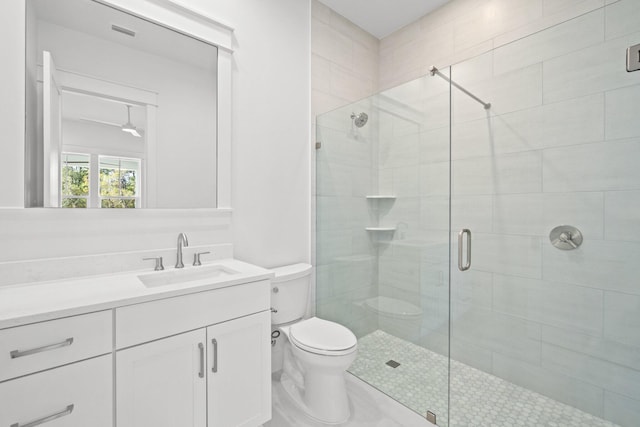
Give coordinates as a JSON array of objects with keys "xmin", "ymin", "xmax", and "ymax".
[{"xmin": 207, "ymin": 311, "xmax": 271, "ymax": 427}]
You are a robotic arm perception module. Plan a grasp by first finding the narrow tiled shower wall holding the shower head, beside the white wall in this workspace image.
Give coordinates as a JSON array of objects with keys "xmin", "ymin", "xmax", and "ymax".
[{"xmin": 310, "ymin": 0, "xmax": 379, "ymax": 335}]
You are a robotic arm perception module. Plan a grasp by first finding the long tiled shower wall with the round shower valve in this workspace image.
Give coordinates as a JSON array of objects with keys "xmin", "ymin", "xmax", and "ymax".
[{"xmin": 379, "ymin": 0, "xmax": 640, "ymax": 426}]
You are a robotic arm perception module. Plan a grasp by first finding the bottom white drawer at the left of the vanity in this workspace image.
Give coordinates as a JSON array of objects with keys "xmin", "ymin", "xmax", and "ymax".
[{"xmin": 0, "ymin": 355, "xmax": 113, "ymax": 427}]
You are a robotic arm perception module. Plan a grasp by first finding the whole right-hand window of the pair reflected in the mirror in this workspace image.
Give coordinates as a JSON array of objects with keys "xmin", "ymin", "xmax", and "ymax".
[{"xmin": 100, "ymin": 156, "xmax": 140, "ymax": 208}]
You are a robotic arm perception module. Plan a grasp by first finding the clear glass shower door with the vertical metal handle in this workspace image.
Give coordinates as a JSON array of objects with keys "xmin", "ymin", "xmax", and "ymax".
[{"xmin": 450, "ymin": 1, "xmax": 640, "ymax": 427}]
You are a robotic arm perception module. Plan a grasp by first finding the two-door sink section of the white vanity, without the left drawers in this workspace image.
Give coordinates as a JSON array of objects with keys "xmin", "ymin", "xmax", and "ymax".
[{"xmin": 116, "ymin": 281, "xmax": 271, "ymax": 427}]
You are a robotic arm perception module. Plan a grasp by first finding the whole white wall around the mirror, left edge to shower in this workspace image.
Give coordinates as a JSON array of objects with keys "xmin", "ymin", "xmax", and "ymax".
[{"xmin": 0, "ymin": 0, "xmax": 309, "ymax": 278}]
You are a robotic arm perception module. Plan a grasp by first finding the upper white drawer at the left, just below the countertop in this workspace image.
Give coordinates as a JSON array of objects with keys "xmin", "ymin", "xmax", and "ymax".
[{"xmin": 0, "ymin": 310, "xmax": 113, "ymax": 381}]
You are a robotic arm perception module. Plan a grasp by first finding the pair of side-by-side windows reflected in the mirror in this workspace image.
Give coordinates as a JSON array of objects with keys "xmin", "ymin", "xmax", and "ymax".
[{"xmin": 60, "ymin": 153, "xmax": 141, "ymax": 208}]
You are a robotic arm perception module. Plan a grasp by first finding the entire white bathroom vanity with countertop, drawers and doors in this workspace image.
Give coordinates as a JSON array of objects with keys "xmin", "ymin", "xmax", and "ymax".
[{"xmin": 0, "ymin": 259, "xmax": 272, "ymax": 427}]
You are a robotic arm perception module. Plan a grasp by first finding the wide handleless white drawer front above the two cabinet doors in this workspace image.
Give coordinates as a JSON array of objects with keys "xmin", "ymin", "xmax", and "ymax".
[{"xmin": 116, "ymin": 280, "xmax": 271, "ymax": 349}]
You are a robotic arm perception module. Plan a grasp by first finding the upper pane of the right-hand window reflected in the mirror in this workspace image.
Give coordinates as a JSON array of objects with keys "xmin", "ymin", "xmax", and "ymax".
[{"xmin": 100, "ymin": 156, "xmax": 140, "ymax": 198}]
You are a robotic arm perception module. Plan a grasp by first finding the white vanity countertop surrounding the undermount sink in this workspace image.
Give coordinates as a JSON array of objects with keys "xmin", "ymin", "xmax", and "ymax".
[{"xmin": 0, "ymin": 259, "xmax": 273, "ymax": 329}]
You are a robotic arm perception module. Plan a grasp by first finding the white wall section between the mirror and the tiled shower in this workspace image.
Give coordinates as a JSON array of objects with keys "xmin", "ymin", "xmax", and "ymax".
[{"xmin": 190, "ymin": 0, "xmax": 310, "ymax": 267}]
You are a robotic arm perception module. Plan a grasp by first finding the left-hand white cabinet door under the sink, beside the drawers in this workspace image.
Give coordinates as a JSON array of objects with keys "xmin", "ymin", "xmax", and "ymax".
[{"xmin": 116, "ymin": 329, "xmax": 207, "ymax": 427}]
